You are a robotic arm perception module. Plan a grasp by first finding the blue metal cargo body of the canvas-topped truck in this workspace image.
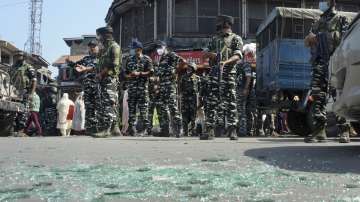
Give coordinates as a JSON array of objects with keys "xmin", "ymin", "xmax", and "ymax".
[{"xmin": 256, "ymin": 39, "xmax": 312, "ymax": 92}]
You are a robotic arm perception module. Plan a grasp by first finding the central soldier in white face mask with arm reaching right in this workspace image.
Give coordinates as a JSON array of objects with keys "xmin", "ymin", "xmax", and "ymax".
[{"xmin": 156, "ymin": 41, "xmax": 185, "ymax": 137}]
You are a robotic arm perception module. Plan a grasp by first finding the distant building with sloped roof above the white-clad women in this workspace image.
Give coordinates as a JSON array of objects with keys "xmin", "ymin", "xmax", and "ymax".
[{"xmin": 53, "ymin": 35, "xmax": 96, "ymax": 100}]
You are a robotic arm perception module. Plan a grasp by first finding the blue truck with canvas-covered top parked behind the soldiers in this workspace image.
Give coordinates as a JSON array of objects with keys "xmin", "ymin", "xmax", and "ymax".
[{"xmin": 256, "ymin": 7, "xmax": 356, "ymax": 136}]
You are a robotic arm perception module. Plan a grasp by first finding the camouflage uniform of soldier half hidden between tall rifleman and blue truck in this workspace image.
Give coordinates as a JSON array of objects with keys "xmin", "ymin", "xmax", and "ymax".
[{"xmin": 236, "ymin": 63, "xmax": 253, "ymax": 136}]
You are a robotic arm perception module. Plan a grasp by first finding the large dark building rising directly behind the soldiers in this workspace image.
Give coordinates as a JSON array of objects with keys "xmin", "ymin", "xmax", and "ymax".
[{"xmin": 105, "ymin": 0, "xmax": 360, "ymax": 53}]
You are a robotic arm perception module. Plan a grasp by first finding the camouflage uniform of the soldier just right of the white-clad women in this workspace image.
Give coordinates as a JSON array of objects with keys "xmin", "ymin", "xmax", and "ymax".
[{"xmin": 78, "ymin": 55, "xmax": 100, "ymax": 132}]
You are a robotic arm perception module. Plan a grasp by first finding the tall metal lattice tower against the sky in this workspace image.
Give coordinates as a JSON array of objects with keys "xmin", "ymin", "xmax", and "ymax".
[{"xmin": 25, "ymin": 0, "xmax": 43, "ymax": 55}]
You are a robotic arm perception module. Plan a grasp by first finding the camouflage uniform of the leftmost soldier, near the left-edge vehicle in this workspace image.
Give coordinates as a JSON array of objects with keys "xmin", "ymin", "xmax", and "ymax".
[{"xmin": 11, "ymin": 62, "xmax": 36, "ymax": 131}]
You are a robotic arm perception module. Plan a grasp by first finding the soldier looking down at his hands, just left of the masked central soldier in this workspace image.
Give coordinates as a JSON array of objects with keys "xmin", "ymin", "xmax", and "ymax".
[{"xmin": 125, "ymin": 40, "xmax": 154, "ymax": 136}]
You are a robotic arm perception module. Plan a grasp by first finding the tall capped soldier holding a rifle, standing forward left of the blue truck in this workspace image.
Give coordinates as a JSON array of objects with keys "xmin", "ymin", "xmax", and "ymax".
[{"xmin": 200, "ymin": 15, "xmax": 243, "ymax": 140}]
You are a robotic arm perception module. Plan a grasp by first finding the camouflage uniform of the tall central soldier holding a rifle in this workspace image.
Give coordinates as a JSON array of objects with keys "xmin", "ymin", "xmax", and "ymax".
[{"xmin": 206, "ymin": 33, "xmax": 243, "ymax": 133}]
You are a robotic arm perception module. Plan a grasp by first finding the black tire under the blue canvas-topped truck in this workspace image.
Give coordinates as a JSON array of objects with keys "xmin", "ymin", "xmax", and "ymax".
[{"xmin": 287, "ymin": 111, "xmax": 311, "ymax": 137}]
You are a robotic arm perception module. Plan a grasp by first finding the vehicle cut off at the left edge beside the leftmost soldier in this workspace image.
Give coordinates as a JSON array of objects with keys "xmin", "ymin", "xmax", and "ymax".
[{"xmin": 0, "ymin": 64, "xmax": 25, "ymax": 136}]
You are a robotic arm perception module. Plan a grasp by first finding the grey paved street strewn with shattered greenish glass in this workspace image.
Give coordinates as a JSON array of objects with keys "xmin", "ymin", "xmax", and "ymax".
[{"xmin": 0, "ymin": 137, "xmax": 360, "ymax": 202}]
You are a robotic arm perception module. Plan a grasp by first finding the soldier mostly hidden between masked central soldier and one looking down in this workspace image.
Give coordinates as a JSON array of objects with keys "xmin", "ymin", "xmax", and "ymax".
[{"xmin": 148, "ymin": 64, "xmax": 162, "ymax": 135}]
